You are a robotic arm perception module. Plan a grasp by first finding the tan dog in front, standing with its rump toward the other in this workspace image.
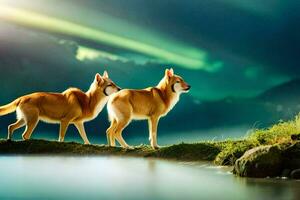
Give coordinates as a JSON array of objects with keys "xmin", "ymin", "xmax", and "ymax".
[{"xmin": 106, "ymin": 69, "xmax": 191, "ymax": 149}]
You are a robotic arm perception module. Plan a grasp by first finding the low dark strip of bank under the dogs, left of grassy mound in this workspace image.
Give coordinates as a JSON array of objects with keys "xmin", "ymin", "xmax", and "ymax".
[{"xmin": 0, "ymin": 139, "xmax": 220, "ymax": 161}]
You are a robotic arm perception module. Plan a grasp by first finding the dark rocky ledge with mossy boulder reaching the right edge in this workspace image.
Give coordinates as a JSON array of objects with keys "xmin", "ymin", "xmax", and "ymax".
[{"xmin": 233, "ymin": 142, "xmax": 300, "ymax": 179}]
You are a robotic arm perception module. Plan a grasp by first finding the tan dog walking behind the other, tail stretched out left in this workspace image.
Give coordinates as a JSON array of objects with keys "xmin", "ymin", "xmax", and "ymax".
[{"xmin": 0, "ymin": 71, "xmax": 120, "ymax": 144}]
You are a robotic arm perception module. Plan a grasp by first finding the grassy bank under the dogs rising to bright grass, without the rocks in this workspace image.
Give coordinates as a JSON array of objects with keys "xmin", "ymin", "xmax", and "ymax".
[{"xmin": 0, "ymin": 114, "xmax": 300, "ymax": 165}]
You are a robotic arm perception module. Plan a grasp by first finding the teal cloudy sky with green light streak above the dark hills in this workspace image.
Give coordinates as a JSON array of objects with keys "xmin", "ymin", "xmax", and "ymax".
[{"xmin": 0, "ymin": 0, "xmax": 300, "ymax": 143}]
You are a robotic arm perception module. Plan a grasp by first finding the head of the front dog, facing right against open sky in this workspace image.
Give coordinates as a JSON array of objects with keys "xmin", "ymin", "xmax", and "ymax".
[{"xmin": 164, "ymin": 68, "xmax": 191, "ymax": 94}]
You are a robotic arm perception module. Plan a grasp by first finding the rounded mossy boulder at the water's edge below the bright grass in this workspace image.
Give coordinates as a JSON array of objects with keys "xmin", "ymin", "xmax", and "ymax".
[{"xmin": 233, "ymin": 145, "xmax": 283, "ymax": 178}]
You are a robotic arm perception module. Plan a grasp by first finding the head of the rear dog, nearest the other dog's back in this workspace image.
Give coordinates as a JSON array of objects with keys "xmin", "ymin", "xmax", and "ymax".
[{"xmin": 92, "ymin": 71, "xmax": 121, "ymax": 96}]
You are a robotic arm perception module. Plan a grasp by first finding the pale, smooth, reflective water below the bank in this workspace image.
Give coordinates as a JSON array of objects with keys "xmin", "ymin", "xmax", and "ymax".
[{"xmin": 0, "ymin": 156, "xmax": 300, "ymax": 200}]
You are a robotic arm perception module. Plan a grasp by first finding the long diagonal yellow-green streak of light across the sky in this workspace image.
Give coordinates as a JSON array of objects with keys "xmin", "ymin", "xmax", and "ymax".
[{"xmin": 0, "ymin": 5, "xmax": 223, "ymax": 71}]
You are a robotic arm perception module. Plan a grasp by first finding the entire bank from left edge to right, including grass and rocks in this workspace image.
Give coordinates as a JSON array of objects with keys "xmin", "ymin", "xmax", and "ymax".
[{"xmin": 0, "ymin": 115, "xmax": 300, "ymax": 178}]
